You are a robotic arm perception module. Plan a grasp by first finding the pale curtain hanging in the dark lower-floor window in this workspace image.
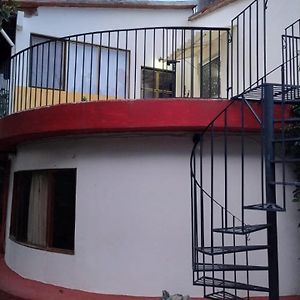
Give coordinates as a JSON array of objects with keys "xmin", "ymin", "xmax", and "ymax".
[{"xmin": 27, "ymin": 173, "xmax": 50, "ymax": 246}]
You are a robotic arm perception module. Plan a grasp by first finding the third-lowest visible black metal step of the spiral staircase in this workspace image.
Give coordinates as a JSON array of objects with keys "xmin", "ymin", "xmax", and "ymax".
[{"xmin": 194, "ymin": 263, "xmax": 269, "ymax": 272}]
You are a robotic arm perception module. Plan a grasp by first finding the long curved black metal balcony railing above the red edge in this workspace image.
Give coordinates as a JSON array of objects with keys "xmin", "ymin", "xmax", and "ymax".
[{"xmin": 0, "ymin": 27, "xmax": 229, "ymax": 113}]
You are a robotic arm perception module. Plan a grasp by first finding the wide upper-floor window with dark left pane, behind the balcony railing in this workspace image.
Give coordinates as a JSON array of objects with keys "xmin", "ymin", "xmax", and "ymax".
[{"xmin": 30, "ymin": 35, "xmax": 130, "ymax": 98}]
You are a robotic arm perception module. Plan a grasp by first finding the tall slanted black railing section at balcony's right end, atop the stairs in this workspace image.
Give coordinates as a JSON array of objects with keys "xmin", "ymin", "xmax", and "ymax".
[{"xmin": 228, "ymin": 0, "xmax": 268, "ymax": 97}]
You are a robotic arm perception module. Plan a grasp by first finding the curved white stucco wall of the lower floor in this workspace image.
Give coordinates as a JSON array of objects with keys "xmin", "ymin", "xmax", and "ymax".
[{"xmin": 5, "ymin": 135, "xmax": 300, "ymax": 296}]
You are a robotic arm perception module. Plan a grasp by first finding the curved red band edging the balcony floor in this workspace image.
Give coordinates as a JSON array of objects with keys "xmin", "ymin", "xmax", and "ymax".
[{"xmin": 0, "ymin": 99, "xmax": 288, "ymax": 151}]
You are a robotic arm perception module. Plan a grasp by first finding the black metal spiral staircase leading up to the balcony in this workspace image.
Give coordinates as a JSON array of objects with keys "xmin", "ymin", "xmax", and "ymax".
[{"xmin": 190, "ymin": 1, "xmax": 300, "ymax": 300}]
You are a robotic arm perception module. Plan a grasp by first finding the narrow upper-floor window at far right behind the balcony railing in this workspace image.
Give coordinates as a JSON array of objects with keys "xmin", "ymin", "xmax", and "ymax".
[{"xmin": 201, "ymin": 57, "xmax": 220, "ymax": 98}]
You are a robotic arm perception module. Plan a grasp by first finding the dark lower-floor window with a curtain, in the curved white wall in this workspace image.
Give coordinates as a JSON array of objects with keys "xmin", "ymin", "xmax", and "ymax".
[{"xmin": 10, "ymin": 169, "xmax": 76, "ymax": 253}]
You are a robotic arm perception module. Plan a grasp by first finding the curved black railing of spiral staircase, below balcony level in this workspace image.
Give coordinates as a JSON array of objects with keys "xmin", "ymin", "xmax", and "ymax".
[{"xmin": 190, "ymin": 99, "xmax": 268, "ymax": 299}]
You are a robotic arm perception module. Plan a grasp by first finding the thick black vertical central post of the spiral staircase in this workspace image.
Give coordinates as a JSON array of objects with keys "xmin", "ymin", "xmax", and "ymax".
[{"xmin": 263, "ymin": 84, "xmax": 279, "ymax": 300}]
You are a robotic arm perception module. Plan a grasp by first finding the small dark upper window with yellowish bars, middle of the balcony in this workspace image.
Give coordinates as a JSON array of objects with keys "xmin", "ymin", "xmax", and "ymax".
[{"xmin": 141, "ymin": 67, "xmax": 176, "ymax": 98}]
